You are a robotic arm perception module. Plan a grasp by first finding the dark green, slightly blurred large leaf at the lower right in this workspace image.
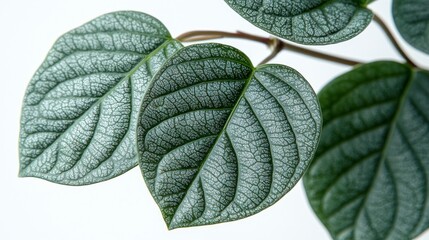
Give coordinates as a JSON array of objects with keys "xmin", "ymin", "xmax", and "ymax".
[{"xmin": 304, "ymin": 62, "xmax": 429, "ymax": 240}]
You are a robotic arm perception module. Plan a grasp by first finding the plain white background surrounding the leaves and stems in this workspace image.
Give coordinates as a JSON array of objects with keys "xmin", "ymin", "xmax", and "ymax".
[{"xmin": 0, "ymin": 0, "xmax": 429, "ymax": 240}]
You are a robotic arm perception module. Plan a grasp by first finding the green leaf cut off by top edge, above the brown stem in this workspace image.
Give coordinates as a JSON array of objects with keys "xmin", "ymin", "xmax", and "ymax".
[{"xmin": 225, "ymin": 0, "xmax": 372, "ymax": 45}]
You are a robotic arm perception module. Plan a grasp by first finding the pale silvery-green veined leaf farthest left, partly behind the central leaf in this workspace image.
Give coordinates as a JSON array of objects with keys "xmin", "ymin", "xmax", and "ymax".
[{"xmin": 20, "ymin": 12, "xmax": 181, "ymax": 185}]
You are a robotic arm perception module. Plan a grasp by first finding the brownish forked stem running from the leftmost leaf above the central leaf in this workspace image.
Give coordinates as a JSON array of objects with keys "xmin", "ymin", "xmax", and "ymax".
[{"xmin": 176, "ymin": 31, "xmax": 361, "ymax": 66}]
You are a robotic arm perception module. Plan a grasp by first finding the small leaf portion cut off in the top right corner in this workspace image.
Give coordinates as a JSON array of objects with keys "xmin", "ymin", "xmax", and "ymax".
[{"xmin": 392, "ymin": 0, "xmax": 429, "ymax": 54}]
